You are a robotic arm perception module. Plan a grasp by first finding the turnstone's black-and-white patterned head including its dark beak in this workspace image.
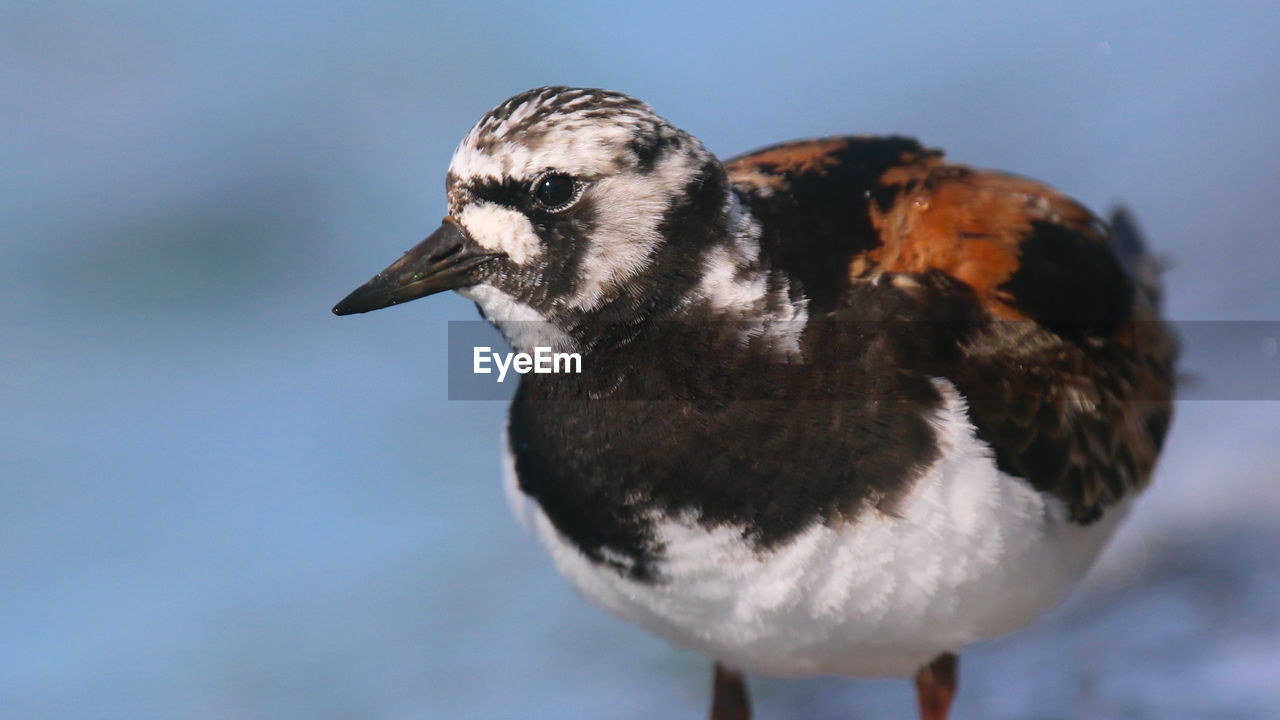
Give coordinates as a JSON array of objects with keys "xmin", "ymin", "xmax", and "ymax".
[{"xmin": 334, "ymin": 87, "xmax": 731, "ymax": 350}]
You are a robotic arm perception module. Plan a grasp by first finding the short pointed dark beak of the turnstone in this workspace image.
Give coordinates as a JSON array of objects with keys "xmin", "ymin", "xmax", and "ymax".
[{"xmin": 333, "ymin": 218, "xmax": 502, "ymax": 315}]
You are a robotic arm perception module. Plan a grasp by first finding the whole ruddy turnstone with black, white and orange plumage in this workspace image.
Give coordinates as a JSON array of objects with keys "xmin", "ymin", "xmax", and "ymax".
[{"xmin": 334, "ymin": 86, "xmax": 1178, "ymax": 720}]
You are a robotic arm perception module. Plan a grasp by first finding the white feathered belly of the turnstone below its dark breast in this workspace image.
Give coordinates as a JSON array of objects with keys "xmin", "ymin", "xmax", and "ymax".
[{"xmin": 506, "ymin": 380, "xmax": 1125, "ymax": 676}]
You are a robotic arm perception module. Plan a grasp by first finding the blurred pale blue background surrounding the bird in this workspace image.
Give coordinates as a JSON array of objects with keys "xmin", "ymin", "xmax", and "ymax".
[{"xmin": 0, "ymin": 0, "xmax": 1280, "ymax": 719}]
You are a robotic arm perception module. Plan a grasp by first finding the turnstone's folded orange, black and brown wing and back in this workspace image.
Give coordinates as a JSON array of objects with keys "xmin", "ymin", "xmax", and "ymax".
[{"xmin": 726, "ymin": 137, "xmax": 1176, "ymax": 521}]
